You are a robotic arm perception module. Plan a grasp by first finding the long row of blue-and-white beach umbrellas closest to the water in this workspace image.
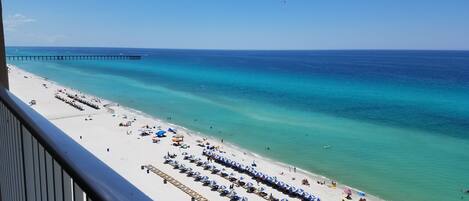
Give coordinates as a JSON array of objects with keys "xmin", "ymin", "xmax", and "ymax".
[{"xmin": 202, "ymin": 149, "xmax": 320, "ymax": 201}]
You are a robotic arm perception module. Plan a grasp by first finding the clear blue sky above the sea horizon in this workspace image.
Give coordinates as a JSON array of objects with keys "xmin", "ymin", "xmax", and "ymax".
[{"xmin": 3, "ymin": 0, "xmax": 469, "ymax": 50}]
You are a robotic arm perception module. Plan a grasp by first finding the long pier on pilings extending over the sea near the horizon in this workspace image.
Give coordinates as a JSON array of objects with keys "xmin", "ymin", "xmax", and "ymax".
[{"xmin": 6, "ymin": 55, "xmax": 142, "ymax": 61}]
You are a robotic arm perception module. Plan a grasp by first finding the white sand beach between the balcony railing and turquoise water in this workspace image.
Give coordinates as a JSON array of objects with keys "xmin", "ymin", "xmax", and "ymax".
[{"xmin": 8, "ymin": 65, "xmax": 380, "ymax": 201}]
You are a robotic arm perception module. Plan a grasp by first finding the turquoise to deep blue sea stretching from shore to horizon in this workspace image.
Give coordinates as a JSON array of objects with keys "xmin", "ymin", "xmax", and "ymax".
[{"xmin": 7, "ymin": 47, "xmax": 469, "ymax": 200}]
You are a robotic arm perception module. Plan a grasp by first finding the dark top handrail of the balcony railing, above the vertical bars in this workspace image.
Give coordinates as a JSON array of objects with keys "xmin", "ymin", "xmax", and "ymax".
[{"xmin": 0, "ymin": 87, "xmax": 151, "ymax": 201}]
